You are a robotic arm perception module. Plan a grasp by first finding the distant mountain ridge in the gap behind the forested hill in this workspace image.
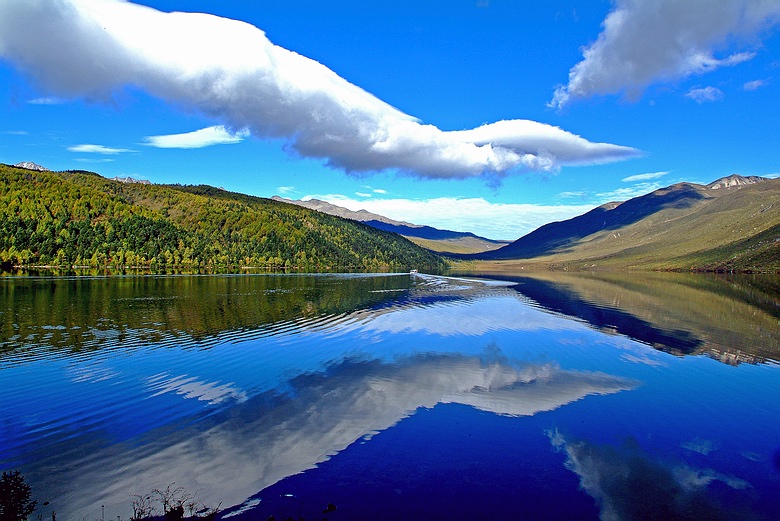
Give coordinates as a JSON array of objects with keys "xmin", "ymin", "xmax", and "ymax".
[{"xmin": 272, "ymin": 196, "xmax": 507, "ymax": 253}]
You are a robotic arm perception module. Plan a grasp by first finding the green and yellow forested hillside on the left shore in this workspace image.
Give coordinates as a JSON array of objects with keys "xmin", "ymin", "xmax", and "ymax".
[{"xmin": 0, "ymin": 164, "xmax": 445, "ymax": 272}]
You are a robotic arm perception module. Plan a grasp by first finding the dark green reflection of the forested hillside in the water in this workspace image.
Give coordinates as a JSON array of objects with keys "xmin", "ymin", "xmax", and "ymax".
[{"xmin": 0, "ymin": 275, "xmax": 410, "ymax": 353}]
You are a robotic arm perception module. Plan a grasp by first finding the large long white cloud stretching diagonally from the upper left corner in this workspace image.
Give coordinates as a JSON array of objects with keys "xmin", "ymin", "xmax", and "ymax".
[{"xmin": 0, "ymin": 0, "xmax": 638, "ymax": 178}]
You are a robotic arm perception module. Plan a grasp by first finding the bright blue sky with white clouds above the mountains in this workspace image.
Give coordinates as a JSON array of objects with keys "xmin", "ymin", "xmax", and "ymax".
[{"xmin": 0, "ymin": 0, "xmax": 780, "ymax": 239}]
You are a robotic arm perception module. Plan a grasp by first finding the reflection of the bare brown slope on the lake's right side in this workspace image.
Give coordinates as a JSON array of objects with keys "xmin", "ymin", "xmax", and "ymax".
[{"xmin": 476, "ymin": 272, "xmax": 780, "ymax": 365}]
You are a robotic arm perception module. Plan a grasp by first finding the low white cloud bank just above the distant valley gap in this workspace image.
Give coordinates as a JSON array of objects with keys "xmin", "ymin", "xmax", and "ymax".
[{"xmin": 303, "ymin": 195, "xmax": 595, "ymax": 240}]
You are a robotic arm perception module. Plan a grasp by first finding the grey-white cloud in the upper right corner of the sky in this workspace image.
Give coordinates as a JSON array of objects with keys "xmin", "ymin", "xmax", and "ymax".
[{"xmin": 549, "ymin": 0, "xmax": 780, "ymax": 108}]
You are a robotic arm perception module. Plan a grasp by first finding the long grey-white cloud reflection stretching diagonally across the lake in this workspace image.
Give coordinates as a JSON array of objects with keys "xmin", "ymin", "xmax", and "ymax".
[{"xmin": 41, "ymin": 349, "xmax": 636, "ymax": 518}]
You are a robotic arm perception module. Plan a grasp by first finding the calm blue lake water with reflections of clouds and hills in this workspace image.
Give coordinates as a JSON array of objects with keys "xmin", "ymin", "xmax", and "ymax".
[{"xmin": 0, "ymin": 274, "xmax": 780, "ymax": 521}]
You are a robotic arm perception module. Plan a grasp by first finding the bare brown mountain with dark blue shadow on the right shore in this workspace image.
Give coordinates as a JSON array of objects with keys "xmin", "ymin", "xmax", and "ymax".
[{"xmin": 471, "ymin": 176, "xmax": 780, "ymax": 271}]
